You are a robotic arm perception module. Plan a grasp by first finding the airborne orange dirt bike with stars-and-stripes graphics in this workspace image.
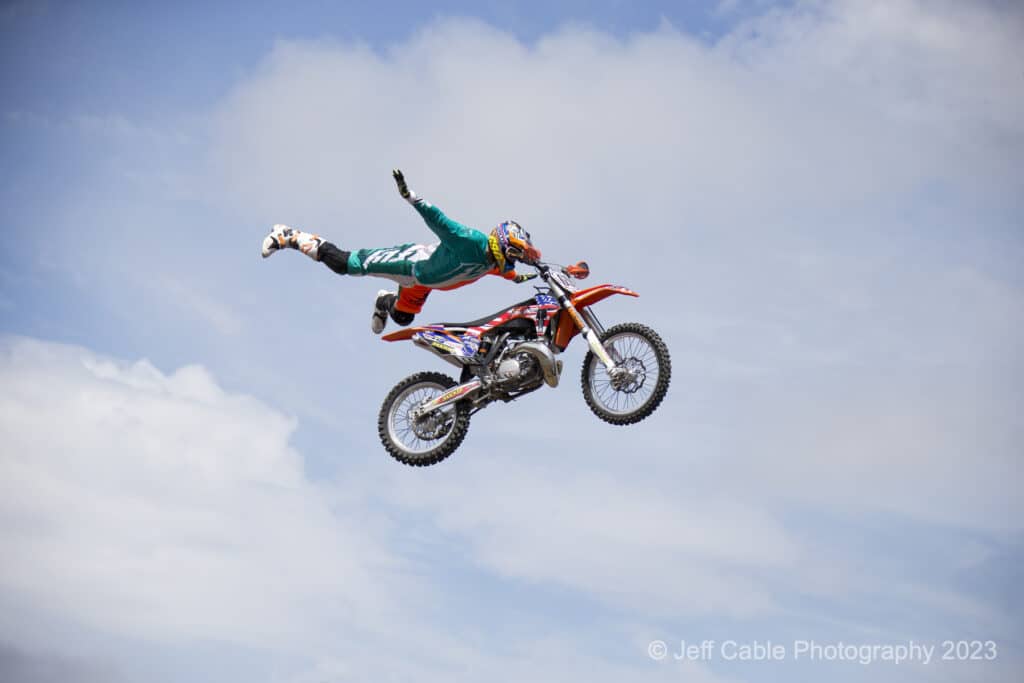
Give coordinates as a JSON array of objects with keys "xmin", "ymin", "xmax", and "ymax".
[{"xmin": 377, "ymin": 261, "xmax": 672, "ymax": 466}]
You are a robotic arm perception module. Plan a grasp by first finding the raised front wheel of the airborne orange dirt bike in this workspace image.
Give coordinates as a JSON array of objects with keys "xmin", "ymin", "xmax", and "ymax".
[{"xmin": 581, "ymin": 323, "xmax": 672, "ymax": 425}]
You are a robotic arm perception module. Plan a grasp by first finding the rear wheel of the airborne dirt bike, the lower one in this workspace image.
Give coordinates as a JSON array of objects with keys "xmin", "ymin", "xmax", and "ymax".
[{"xmin": 377, "ymin": 373, "xmax": 469, "ymax": 467}]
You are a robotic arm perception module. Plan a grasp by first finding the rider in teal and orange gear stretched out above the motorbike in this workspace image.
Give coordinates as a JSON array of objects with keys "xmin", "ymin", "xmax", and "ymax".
[{"xmin": 262, "ymin": 169, "xmax": 541, "ymax": 334}]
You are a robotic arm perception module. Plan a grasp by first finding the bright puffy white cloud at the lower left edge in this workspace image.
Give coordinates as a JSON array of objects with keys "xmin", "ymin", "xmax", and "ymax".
[{"xmin": 0, "ymin": 339, "xmax": 395, "ymax": 648}]
